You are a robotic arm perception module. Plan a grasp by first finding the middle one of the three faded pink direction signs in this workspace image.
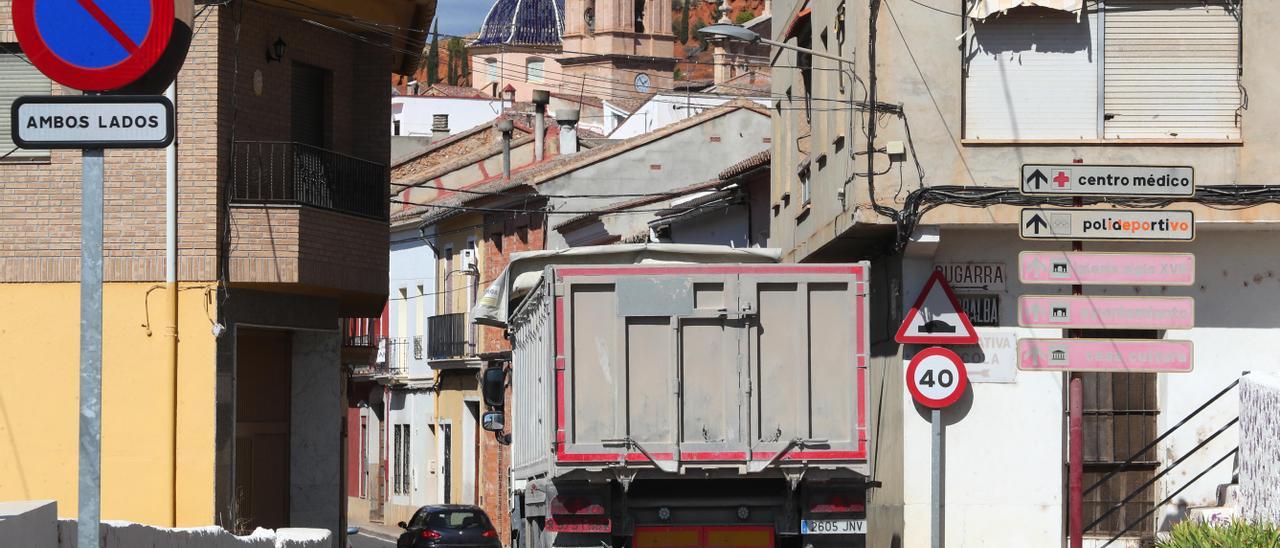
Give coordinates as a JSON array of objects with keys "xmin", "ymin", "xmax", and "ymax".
[{"xmin": 1018, "ymin": 294, "xmax": 1196, "ymax": 329}]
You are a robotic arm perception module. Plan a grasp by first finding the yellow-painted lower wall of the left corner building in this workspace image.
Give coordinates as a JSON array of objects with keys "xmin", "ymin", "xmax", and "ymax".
[{"xmin": 0, "ymin": 283, "xmax": 216, "ymax": 526}]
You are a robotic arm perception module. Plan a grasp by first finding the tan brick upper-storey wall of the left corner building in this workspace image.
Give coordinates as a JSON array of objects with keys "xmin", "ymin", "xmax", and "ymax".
[{"xmin": 0, "ymin": 0, "xmax": 393, "ymax": 299}]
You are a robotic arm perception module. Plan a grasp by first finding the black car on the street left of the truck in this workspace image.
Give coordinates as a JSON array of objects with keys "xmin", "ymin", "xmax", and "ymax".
[{"xmin": 396, "ymin": 504, "xmax": 502, "ymax": 548}]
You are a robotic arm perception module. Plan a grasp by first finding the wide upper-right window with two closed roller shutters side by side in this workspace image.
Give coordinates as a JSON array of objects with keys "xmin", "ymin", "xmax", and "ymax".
[{"xmin": 963, "ymin": 0, "xmax": 1243, "ymax": 141}]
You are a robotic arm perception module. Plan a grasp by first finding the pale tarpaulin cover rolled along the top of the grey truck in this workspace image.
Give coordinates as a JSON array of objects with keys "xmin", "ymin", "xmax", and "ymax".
[{"xmin": 471, "ymin": 243, "xmax": 782, "ymax": 328}]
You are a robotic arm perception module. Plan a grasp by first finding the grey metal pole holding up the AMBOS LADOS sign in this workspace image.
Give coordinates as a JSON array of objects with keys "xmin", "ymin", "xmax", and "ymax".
[{"xmin": 76, "ymin": 144, "xmax": 102, "ymax": 548}]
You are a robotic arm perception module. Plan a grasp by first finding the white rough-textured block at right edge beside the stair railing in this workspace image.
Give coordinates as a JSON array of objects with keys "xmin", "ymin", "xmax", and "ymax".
[{"xmin": 1236, "ymin": 373, "xmax": 1280, "ymax": 524}]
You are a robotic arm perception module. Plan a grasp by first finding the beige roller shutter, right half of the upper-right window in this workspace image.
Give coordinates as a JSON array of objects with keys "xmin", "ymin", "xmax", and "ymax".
[{"xmin": 1103, "ymin": 0, "xmax": 1240, "ymax": 140}]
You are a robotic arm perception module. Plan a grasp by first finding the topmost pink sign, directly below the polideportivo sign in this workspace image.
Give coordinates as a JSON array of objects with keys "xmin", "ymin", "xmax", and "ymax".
[{"xmin": 1018, "ymin": 251, "xmax": 1196, "ymax": 286}]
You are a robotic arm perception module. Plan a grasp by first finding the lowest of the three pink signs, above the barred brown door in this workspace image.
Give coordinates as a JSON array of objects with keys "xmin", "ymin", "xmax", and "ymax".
[{"xmin": 1018, "ymin": 339, "xmax": 1192, "ymax": 373}]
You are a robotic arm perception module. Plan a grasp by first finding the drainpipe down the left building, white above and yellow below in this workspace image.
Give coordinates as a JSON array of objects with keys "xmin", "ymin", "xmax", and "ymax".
[{"xmin": 164, "ymin": 81, "xmax": 178, "ymax": 528}]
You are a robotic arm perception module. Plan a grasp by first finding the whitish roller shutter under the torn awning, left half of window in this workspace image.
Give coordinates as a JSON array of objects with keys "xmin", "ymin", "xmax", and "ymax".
[{"xmin": 965, "ymin": 8, "xmax": 1098, "ymax": 140}]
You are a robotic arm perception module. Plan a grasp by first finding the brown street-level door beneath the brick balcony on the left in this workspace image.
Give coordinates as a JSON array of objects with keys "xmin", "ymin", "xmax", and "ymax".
[{"xmin": 233, "ymin": 329, "xmax": 293, "ymax": 530}]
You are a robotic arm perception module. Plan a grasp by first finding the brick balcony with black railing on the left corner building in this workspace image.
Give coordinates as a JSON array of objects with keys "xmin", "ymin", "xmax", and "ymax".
[{"xmin": 227, "ymin": 141, "xmax": 389, "ymax": 316}]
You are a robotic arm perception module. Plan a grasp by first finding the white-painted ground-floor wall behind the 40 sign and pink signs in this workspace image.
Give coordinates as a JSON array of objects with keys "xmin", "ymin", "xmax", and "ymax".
[{"xmin": 872, "ymin": 228, "xmax": 1280, "ymax": 548}]
